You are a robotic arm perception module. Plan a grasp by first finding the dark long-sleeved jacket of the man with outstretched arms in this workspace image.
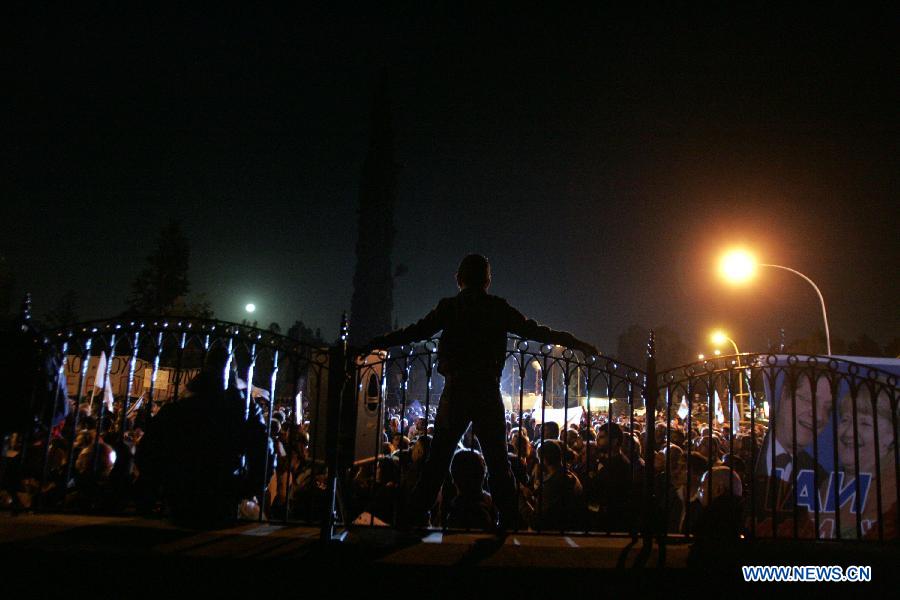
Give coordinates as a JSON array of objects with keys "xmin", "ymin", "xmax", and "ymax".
[{"xmin": 370, "ymin": 288, "xmax": 581, "ymax": 377}]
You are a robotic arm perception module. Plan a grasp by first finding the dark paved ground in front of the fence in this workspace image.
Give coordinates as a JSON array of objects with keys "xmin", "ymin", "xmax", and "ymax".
[{"xmin": 0, "ymin": 513, "xmax": 900, "ymax": 600}]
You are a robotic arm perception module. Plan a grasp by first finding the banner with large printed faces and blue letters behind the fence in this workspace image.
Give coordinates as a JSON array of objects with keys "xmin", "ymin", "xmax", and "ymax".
[{"xmin": 754, "ymin": 355, "xmax": 900, "ymax": 539}]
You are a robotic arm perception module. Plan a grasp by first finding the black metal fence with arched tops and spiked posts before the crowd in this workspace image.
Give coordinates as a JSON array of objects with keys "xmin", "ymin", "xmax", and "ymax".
[{"xmin": 0, "ymin": 302, "xmax": 900, "ymax": 543}]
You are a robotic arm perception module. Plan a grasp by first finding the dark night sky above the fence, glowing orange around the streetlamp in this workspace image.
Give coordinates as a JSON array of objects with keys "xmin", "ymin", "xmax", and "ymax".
[{"xmin": 0, "ymin": 4, "xmax": 900, "ymax": 353}]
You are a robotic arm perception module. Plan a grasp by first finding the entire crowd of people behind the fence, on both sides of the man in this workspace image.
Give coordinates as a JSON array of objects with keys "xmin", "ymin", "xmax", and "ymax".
[{"xmin": 0, "ymin": 384, "xmax": 763, "ymax": 533}]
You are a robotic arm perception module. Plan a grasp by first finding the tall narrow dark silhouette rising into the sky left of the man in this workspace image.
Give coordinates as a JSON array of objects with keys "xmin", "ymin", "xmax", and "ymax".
[{"xmin": 350, "ymin": 69, "xmax": 397, "ymax": 344}]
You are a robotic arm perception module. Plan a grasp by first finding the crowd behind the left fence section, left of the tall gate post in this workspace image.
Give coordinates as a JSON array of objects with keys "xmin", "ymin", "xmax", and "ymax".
[{"xmin": 0, "ymin": 371, "xmax": 324, "ymax": 525}]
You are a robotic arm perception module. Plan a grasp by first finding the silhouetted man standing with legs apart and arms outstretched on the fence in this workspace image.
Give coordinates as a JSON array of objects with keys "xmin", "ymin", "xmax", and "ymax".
[{"xmin": 358, "ymin": 254, "xmax": 597, "ymax": 528}]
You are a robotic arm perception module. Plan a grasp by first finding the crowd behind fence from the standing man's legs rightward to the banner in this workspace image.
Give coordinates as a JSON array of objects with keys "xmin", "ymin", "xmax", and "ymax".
[{"xmin": 352, "ymin": 408, "xmax": 765, "ymax": 537}]
